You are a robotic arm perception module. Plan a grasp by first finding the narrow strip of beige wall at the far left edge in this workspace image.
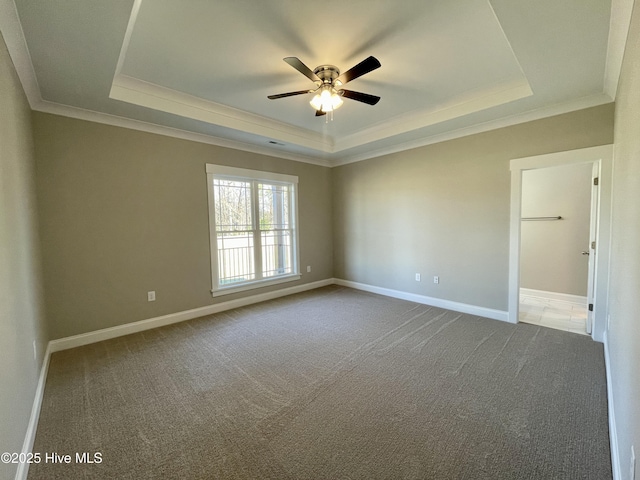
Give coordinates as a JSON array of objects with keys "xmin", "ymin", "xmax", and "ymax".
[{"xmin": 0, "ymin": 36, "xmax": 47, "ymax": 478}]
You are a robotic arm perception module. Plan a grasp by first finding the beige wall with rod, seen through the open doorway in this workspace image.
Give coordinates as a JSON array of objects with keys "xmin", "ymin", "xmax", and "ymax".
[{"xmin": 520, "ymin": 164, "xmax": 593, "ymax": 297}]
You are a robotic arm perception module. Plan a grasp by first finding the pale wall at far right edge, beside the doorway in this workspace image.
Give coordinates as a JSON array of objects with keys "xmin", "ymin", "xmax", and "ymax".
[{"xmin": 607, "ymin": 2, "xmax": 640, "ymax": 480}]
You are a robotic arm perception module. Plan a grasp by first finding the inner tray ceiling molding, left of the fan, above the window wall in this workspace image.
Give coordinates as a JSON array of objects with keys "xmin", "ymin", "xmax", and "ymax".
[{"xmin": 109, "ymin": 75, "xmax": 333, "ymax": 153}]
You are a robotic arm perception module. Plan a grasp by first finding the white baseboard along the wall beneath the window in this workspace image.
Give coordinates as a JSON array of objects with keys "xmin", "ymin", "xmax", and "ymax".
[{"xmin": 49, "ymin": 278, "xmax": 334, "ymax": 353}]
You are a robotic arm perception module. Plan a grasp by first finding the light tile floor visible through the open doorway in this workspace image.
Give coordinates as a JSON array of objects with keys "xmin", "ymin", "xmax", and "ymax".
[{"xmin": 519, "ymin": 294, "xmax": 587, "ymax": 335}]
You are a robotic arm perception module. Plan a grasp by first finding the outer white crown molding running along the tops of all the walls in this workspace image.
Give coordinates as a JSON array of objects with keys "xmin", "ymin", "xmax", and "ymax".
[{"xmin": 0, "ymin": 0, "xmax": 634, "ymax": 171}]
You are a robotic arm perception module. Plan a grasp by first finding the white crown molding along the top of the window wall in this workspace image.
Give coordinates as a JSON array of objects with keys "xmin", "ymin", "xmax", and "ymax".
[{"xmin": 32, "ymin": 100, "xmax": 331, "ymax": 167}]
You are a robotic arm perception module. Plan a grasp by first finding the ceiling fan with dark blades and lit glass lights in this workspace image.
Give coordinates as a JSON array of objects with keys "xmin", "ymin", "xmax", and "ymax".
[{"xmin": 267, "ymin": 57, "xmax": 381, "ymax": 117}]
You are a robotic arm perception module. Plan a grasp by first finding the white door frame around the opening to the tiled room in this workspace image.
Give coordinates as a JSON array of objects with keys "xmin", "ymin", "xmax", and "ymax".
[{"xmin": 509, "ymin": 145, "xmax": 613, "ymax": 342}]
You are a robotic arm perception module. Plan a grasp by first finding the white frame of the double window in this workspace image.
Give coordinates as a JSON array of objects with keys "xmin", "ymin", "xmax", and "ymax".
[{"xmin": 206, "ymin": 163, "xmax": 301, "ymax": 297}]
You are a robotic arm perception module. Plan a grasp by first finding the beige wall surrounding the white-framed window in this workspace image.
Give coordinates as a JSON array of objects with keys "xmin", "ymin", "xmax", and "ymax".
[{"xmin": 34, "ymin": 113, "xmax": 333, "ymax": 339}]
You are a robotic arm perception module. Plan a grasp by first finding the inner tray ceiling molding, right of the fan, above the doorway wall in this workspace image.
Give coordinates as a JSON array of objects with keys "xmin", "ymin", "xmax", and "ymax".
[{"xmin": 334, "ymin": 80, "xmax": 533, "ymax": 152}]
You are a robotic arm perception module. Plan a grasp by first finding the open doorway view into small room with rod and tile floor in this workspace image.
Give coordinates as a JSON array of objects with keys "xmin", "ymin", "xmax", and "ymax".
[{"xmin": 518, "ymin": 163, "xmax": 598, "ymax": 335}]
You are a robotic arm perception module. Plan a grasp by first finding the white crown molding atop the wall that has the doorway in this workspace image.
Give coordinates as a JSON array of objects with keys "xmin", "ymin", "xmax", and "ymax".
[{"xmin": 331, "ymin": 93, "xmax": 613, "ymax": 167}]
